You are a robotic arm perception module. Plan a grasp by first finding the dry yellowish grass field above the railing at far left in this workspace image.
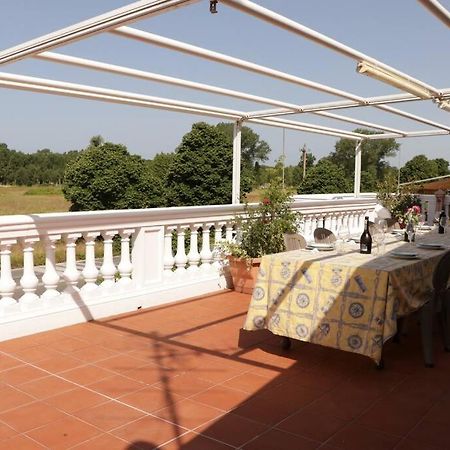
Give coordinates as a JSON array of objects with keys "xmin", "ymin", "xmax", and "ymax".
[{"xmin": 0, "ymin": 186, "xmax": 70, "ymax": 216}]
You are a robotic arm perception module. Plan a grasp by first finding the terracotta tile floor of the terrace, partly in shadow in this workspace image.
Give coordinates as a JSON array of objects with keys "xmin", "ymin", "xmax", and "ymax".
[{"xmin": 0, "ymin": 292, "xmax": 450, "ymax": 450}]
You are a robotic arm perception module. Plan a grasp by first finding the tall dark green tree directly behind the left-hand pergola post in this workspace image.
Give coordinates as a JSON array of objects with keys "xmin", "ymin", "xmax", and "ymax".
[{"xmin": 167, "ymin": 122, "xmax": 251, "ymax": 206}]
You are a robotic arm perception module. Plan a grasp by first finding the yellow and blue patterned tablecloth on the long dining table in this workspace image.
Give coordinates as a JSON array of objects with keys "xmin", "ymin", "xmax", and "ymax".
[{"xmin": 244, "ymin": 233, "xmax": 450, "ymax": 362}]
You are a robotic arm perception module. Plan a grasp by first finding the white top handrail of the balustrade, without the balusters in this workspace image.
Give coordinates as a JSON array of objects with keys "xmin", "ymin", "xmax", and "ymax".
[{"xmin": 0, "ymin": 198, "xmax": 376, "ymax": 239}]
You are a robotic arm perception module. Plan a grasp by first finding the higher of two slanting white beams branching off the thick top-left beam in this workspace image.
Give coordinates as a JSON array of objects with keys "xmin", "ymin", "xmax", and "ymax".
[{"xmin": 111, "ymin": 27, "xmax": 450, "ymax": 130}]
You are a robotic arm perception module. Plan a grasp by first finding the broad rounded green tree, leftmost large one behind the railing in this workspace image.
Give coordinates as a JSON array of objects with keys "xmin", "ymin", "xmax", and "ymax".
[{"xmin": 63, "ymin": 142, "xmax": 162, "ymax": 211}]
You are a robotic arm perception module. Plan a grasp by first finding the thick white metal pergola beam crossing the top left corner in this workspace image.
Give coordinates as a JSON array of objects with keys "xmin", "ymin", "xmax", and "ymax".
[{"xmin": 0, "ymin": 0, "xmax": 199, "ymax": 64}]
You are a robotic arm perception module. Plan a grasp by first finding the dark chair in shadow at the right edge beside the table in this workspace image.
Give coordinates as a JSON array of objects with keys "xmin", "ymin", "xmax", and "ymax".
[{"xmin": 420, "ymin": 252, "xmax": 450, "ymax": 367}]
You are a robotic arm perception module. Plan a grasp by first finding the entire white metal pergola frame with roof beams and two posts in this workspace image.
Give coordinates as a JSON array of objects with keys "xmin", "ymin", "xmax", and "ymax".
[{"xmin": 0, "ymin": 0, "xmax": 450, "ymax": 204}]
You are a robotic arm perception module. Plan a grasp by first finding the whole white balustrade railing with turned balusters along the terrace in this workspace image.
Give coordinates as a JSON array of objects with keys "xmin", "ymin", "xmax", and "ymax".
[{"xmin": 0, "ymin": 198, "xmax": 376, "ymax": 340}]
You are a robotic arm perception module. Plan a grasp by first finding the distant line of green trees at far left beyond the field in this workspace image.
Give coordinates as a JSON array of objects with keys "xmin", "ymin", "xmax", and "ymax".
[{"xmin": 0, "ymin": 143, "xmax": 79, "ymax": 186}]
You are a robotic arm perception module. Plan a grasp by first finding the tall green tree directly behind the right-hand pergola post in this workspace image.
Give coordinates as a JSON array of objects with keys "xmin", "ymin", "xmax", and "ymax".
[{"xmin": 329, "ymin": 128, "xmax": 400, "ymax": 180}]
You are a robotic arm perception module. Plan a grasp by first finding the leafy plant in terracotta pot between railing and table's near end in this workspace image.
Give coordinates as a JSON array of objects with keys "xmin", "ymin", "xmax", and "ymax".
[{"xmin": 220, "ymin": 180, "xmax": 300, "ymax": 293}]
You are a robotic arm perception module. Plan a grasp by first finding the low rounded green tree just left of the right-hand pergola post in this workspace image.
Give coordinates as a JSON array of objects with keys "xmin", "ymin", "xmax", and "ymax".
[{"xmin": 298, "ymin": 158, "xmax": 352, "ymax": 194}]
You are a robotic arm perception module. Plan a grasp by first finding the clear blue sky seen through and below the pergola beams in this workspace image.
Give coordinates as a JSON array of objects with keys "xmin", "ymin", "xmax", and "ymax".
[{"xmin": 0, "ymin": 0, "xmax": 450, "ymax": 165}]
